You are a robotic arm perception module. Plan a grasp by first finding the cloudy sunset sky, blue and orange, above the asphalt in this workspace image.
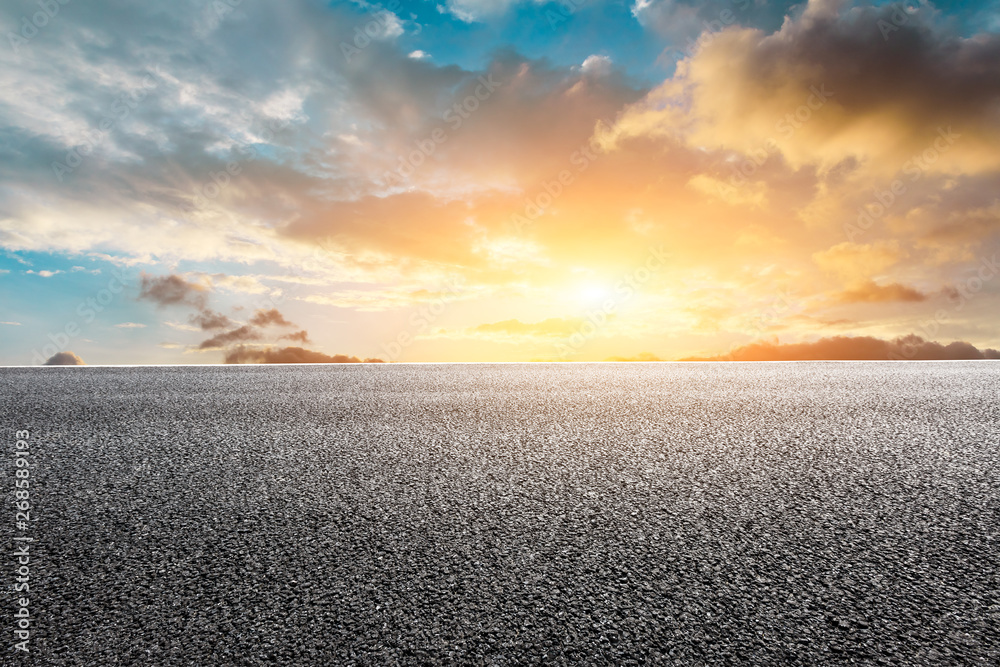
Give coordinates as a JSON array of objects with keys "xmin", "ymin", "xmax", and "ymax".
[{"xmin": 0, "ymin": 0, "xmax": 1000, "ymax": 365}]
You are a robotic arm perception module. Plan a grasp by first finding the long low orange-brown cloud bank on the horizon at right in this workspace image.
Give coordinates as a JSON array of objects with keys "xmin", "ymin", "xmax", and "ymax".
[{"xmin": 684, "ymin": 334, "xmax": 1000, "ymax": 361}]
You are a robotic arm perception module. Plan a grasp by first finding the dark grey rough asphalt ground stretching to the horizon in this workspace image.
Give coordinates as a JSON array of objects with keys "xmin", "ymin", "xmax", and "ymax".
[{"xmin": 0, "ymin": 362, "xmax": 1000, "ymax": 665}]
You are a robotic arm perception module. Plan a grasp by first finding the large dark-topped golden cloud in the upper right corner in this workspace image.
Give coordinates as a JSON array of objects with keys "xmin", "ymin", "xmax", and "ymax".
[{"xmin": 604, "ymin": 0, "xmax": 1000, "ymax": 174}]
